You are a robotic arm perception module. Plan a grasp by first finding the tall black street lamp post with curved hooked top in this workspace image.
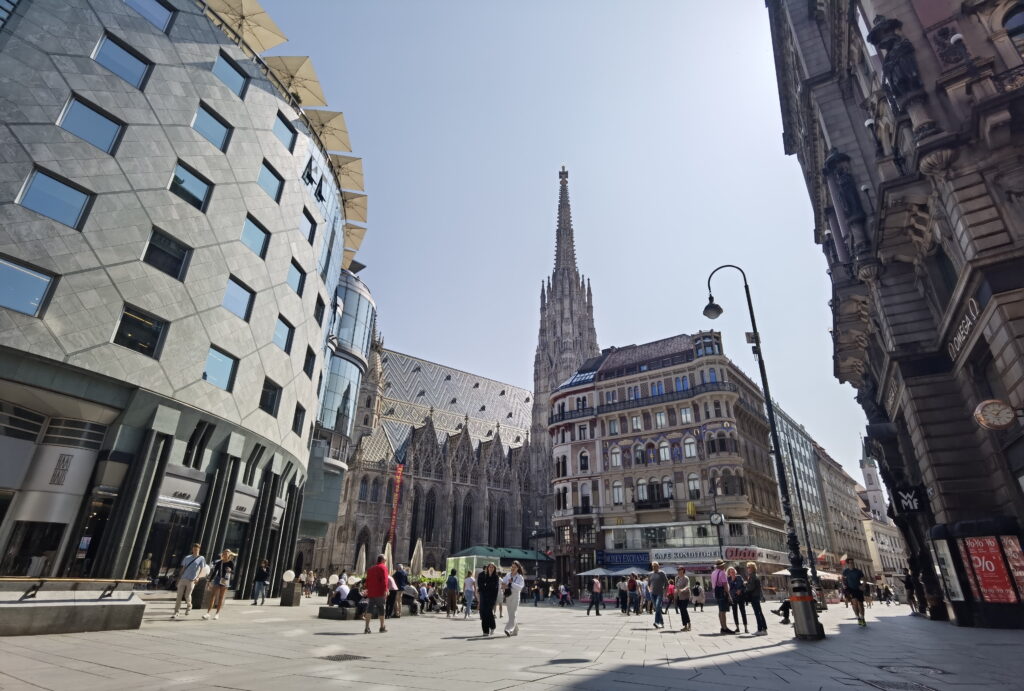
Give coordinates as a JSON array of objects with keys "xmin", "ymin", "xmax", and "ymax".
[{"xmin": 703, "ymin": 264, "xmax": 825, "ymax": 641}]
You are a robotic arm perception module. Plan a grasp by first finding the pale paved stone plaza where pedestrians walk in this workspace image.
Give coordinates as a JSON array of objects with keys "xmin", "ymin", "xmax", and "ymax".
[{"xmin": 0, "ymin": 598, "xmax": 1024, "ymax": 691}]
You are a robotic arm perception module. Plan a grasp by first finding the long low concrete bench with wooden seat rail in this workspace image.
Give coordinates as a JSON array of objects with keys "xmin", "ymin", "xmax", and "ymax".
[{"xmin": 0, "ymin": 578, "xmax": 146, "ymax": 636}]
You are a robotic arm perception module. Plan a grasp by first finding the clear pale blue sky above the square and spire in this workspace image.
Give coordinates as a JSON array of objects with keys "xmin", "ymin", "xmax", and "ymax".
[{"xmin": 263, "ymin": 0, "xmax": 864, "ymax": 481}]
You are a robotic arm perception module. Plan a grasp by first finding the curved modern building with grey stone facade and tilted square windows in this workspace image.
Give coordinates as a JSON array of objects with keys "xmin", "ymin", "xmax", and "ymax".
[{"xmin": 0, "ymin": 0, "xmax": 366, "ymax": 596}]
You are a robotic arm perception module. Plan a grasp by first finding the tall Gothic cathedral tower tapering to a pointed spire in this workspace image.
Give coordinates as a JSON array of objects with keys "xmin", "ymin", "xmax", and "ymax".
[{"xmin": 523, "ymin": 166, "xmax": 599, "ymax": 547}]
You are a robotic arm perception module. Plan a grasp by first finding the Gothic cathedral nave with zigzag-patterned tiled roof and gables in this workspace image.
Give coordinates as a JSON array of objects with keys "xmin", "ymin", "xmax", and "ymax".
[{"xmin": 302, "ymin": 348, "xmax": 532, "ymax": 572}]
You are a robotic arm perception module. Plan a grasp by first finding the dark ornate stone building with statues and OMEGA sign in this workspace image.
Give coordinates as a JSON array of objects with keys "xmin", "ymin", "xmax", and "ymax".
[{"xmin": 767, "ymin": 0, "xmax": 1024, "ymax": 627}]
